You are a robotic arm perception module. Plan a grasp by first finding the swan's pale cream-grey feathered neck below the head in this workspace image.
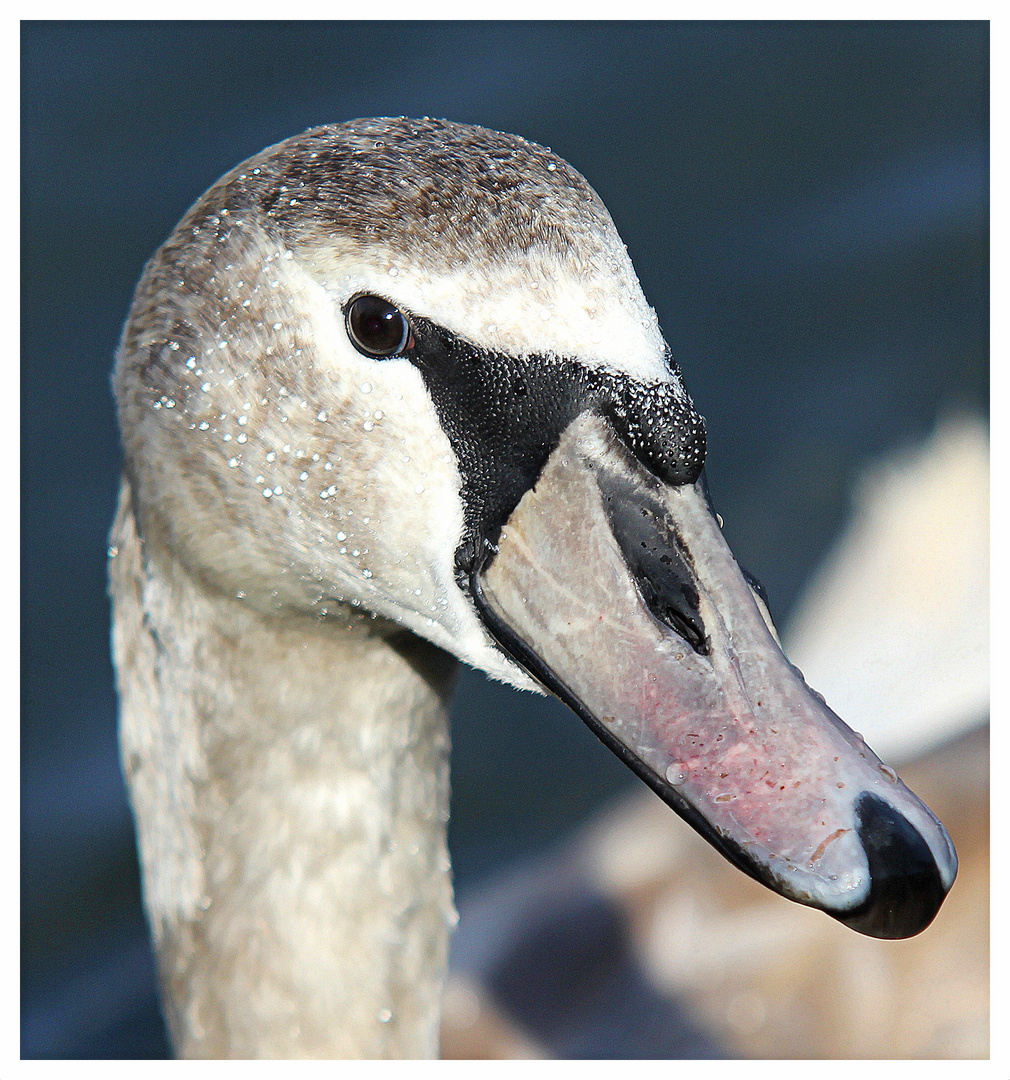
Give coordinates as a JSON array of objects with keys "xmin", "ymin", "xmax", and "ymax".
[{"xmin": 110, "ymin": 483, "xmax": 455, "ymax": 1057}]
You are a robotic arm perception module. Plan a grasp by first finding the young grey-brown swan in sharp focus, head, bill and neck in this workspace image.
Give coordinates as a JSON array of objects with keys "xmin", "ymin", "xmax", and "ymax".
[{"xmin": 111, "ymin": 119, "xmax": 956, "ymax": 1057}]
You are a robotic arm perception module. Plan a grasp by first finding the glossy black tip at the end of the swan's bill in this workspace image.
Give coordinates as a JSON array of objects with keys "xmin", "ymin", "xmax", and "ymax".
[{"xmin": 830, "ymin": 792, "xmax": 947, "ymax": 937}]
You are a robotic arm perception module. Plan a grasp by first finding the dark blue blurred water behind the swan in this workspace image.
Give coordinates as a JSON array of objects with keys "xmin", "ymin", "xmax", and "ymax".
[{"xmin": 22, "ymin": 23, "xmax": 988, "ymax": 1057}]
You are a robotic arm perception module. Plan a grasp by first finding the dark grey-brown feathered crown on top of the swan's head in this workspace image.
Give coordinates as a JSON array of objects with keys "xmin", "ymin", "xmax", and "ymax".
[{"xmin": 212, "ymin": 118, "xmax": 620, "ymax": 270}]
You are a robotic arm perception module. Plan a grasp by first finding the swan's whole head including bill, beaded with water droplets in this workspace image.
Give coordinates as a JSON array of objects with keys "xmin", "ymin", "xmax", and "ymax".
[{"xmin": 115, "ymin": 119, "xmax": 956, "ymax": 936}]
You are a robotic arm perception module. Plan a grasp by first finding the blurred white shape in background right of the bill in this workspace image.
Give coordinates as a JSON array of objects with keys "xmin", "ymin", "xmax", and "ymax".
[{"xmin": 784, "ymin": 416, "xmax": 989, "ymax": 765}]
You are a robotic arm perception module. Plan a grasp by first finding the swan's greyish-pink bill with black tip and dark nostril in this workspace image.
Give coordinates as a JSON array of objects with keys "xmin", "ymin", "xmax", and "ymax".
[{"xmin": 471, "ymin": 411, "xmax": 957, "ymax": 937}]
